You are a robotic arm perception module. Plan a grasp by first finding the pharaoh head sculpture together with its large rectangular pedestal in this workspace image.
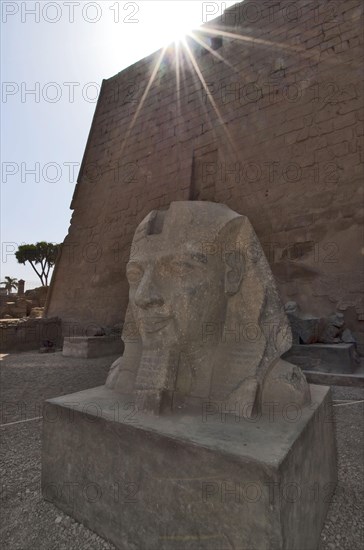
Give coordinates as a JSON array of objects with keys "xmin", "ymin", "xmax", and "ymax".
[{"xmin": 42, "ymin": 201, "xmax": 337, "ymax": 550}]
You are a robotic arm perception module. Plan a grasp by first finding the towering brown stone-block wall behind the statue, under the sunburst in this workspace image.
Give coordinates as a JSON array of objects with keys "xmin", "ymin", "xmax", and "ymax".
[{"xmin": 48, "ymin": 0, "xmax": 364, "ymax": 350}]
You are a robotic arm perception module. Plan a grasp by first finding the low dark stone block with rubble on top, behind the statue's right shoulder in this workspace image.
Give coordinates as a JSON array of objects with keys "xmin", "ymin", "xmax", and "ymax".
[{"xmin": 283, "ymin": 344, "xmax": 359, "ymax": 374}]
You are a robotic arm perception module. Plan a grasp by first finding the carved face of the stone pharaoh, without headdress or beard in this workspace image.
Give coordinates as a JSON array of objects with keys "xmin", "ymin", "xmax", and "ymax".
[{"xmin": 127, "ymin": 243, "xmax": 226, "ymax": 347}]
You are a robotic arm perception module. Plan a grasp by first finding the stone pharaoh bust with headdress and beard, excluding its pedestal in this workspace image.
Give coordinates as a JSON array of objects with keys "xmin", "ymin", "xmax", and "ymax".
[{"xmin": 106, "ymin": 201, "xmax": 310, "ymax": 418}]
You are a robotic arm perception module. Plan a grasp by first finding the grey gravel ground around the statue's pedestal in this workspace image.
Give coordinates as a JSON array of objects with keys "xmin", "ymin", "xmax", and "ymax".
[{"xmin": 0, "ymin": 352, "xmax": 364, "ymax": 550}]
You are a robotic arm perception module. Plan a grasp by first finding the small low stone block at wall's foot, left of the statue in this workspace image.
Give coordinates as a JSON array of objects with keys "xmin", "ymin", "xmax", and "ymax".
[{"xmin": 62, "ymin": 336, "xmax": 124, "ymax": 358}]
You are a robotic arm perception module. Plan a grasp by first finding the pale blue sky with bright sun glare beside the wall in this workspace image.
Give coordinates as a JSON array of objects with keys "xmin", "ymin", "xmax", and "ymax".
[{"xmin": 1, "ymin": 0, "xmax": 235, "ymax": 289}]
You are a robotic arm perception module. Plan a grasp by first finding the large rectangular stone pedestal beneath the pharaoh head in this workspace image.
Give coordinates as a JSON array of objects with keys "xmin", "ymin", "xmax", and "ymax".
[{"xmin": 42, "ymin": 386, "xmax": 337, "ymax": 550}]
